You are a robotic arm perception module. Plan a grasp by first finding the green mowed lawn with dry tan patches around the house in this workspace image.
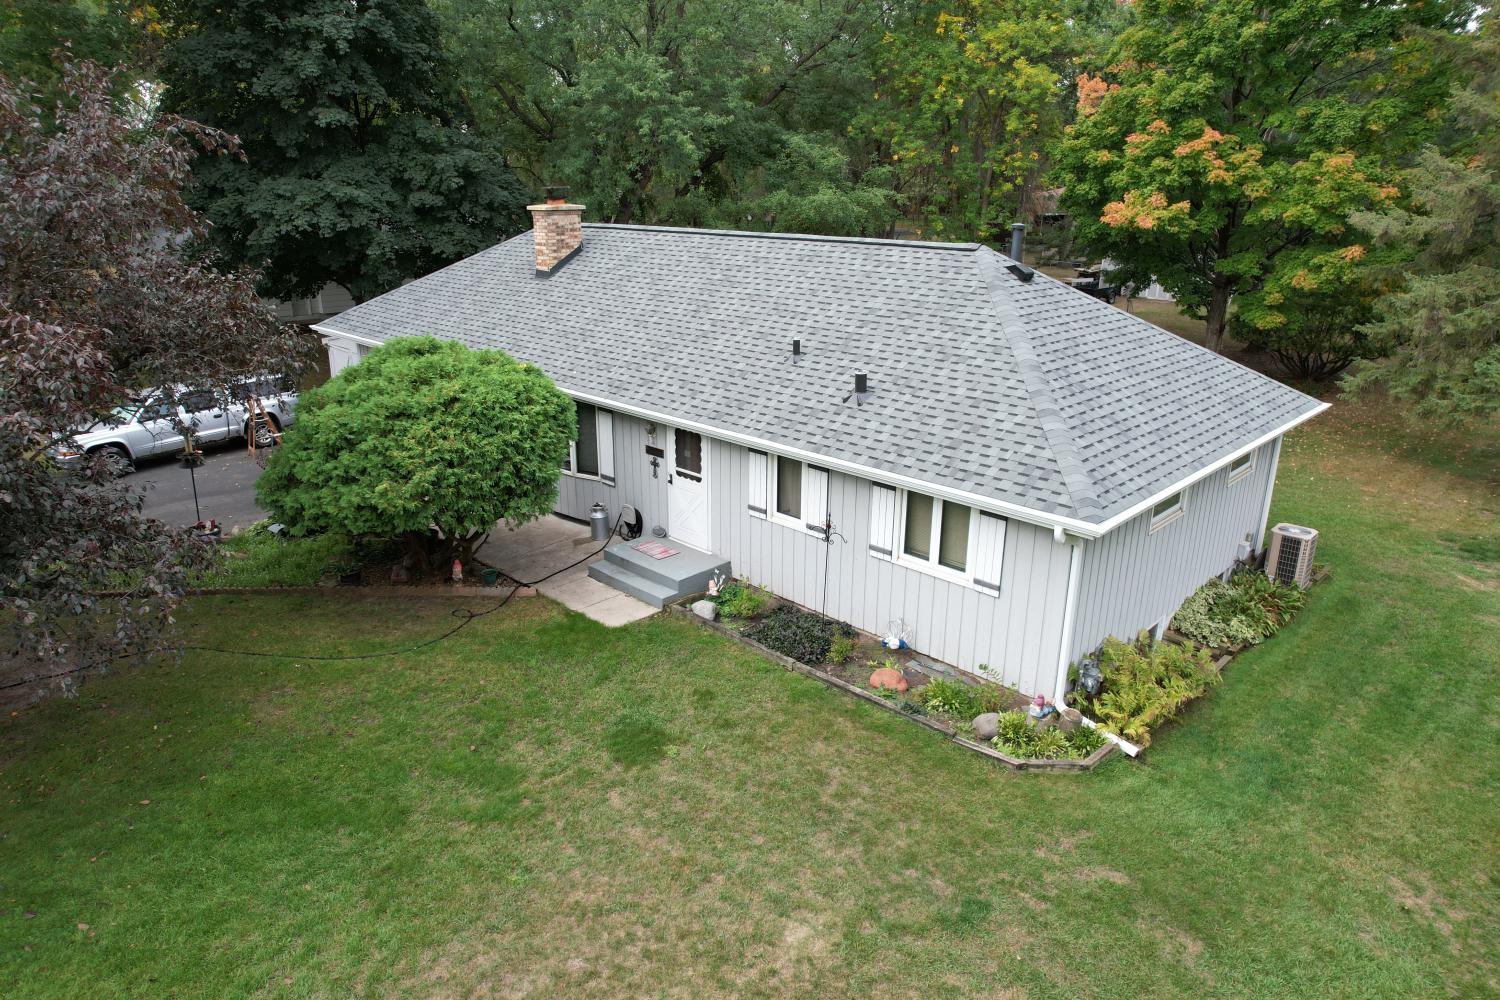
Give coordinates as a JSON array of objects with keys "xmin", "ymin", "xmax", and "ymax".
[{"xmin": 0, "ymin": 408, "xmax": 1500, "ymax": 1000}]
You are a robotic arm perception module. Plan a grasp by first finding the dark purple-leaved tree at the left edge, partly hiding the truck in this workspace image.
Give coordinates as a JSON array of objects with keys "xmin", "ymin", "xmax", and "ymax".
[{"xmin": 0, "ymin": 61, "xmax": 312, "ymax": 692}]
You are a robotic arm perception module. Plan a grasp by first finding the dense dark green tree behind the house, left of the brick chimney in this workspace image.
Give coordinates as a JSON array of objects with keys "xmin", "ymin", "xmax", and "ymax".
[{"xmin": 162, "ymin": 0, "xmax": 527, "ymax": 300}]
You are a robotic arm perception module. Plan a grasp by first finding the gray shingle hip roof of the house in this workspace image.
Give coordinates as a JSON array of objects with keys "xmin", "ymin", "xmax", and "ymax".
[{"xmin": 320, "ymin": 225, "xmax": 1320, "ymax": 523}]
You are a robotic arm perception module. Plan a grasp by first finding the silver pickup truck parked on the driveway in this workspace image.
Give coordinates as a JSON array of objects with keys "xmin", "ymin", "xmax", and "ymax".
[{"xmin": 53, "ymin": 378, "xmax": 297, "ymax": 475}]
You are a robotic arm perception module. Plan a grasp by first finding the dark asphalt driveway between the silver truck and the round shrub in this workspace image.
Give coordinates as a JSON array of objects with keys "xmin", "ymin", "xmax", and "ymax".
[{"xmin": 125, "ymin": 441, "xmax": 266, "ymax": 534}]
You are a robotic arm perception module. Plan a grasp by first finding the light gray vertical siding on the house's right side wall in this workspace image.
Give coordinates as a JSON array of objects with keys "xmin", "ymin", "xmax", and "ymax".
[{"xmin": 1068, "ymin": 441, "xmax": 1277, "ymax": 661}]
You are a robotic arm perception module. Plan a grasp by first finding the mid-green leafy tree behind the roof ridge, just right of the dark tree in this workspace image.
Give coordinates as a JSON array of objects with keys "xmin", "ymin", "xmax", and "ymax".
[{"xmin": 435, "ymin": 0, "xmax": 893, "ymax": 234}]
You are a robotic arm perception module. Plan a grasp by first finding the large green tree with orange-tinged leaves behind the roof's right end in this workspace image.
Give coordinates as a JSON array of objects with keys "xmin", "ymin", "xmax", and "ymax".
[{"xmin": 1056, "ymin": 0, "xmax": 1473, "ymax": 349}]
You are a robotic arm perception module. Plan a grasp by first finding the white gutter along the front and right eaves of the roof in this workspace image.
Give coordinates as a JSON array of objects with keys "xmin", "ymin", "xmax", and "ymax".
[{"xmin": 312, "ymin": 322, "xmax": 1329, "ymax": 540}]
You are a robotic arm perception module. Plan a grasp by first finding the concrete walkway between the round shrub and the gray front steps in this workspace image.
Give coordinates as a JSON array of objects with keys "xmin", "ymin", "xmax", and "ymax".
[{"xmin": 476, "ymin": 516, "xmax": 656, "ymax": 627}]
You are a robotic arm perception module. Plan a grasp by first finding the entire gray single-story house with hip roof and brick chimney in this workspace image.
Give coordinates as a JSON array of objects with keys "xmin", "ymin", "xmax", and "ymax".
[{"xmin": 315, "ymin": 202, "xmax": 1325, "ymax": 699}]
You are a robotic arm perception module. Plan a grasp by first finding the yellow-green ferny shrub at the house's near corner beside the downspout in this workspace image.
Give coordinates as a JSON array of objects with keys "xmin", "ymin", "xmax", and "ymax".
[{"xmin": 1076, "ymin": 631, "xmax": 1221, "ymax": 747}]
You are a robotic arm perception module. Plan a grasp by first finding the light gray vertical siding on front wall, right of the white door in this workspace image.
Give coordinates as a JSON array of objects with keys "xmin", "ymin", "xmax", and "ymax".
[{"xmin": 710, "ymin": 439, "xmax": 1068, "ymax": 694}]
